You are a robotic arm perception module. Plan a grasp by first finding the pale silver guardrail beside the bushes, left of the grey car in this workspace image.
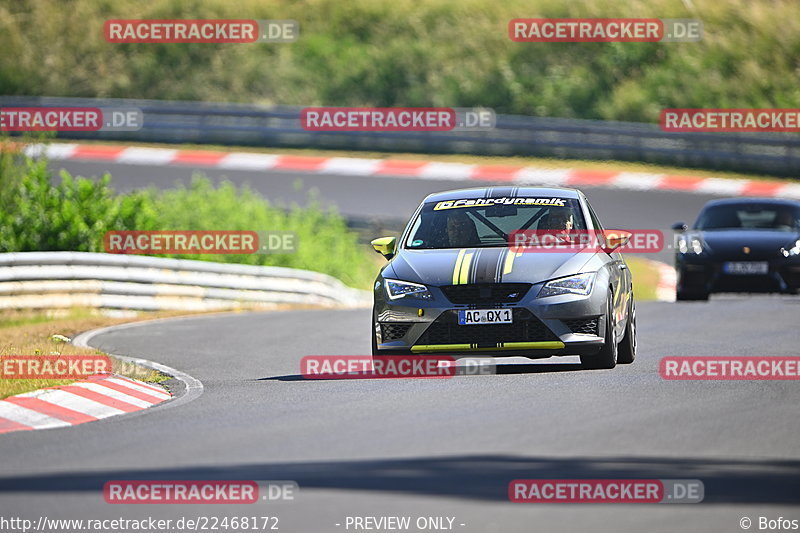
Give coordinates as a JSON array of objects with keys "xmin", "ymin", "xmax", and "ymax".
[{"xmin": 0, "ymin": 252, "xmax": 369, "ymax": 310}]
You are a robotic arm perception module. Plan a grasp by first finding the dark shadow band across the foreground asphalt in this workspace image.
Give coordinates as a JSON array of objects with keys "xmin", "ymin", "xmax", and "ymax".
[{"xmin": 0, "ymin": 455, "xmax": 800, "ymax": 505}]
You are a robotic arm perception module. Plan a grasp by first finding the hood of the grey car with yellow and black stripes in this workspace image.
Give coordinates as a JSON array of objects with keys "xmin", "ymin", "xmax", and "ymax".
[{"xmin": 383, "ymin": 247, "xmax": 604, "ymax": 286}]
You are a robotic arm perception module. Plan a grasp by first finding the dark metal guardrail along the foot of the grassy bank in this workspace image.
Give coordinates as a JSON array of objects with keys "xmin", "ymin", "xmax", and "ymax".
[{"xmin": 0, "ymin": 96, "xmax": 800, "ymax": 177}]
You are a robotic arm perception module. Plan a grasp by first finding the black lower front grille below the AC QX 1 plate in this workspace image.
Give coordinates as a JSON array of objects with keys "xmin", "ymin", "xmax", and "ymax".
[{"xmin": 416, "ymin": 309, "xmax": 558, "ymax": 348}]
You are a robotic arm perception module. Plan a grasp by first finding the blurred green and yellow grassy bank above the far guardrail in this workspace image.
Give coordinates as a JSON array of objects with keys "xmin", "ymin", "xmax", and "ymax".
[{"xmin": 0, "ymin": 0, "xmax": 800, "ymax": 122}]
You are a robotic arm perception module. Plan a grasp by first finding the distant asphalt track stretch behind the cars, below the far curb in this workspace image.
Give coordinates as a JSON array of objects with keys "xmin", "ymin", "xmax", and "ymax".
[{"xmin": 50, "ymin": 161, "xmax": 718, "ymax": 263}]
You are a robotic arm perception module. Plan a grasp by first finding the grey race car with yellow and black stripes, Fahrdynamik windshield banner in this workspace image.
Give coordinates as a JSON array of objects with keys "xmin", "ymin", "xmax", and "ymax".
[{"xmin": 371, "ymin": 187, "xmax": 636, "ymax": 368}]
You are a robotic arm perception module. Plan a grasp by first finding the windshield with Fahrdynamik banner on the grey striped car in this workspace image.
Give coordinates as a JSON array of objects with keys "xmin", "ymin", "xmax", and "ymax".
[{"xmin": 406, "ymin": 198, "xmax": 587, "ymax": 249}]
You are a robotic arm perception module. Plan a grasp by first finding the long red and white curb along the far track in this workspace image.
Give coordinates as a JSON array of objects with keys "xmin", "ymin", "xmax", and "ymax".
[{"xmin": 23, "ymin": 144, "xmax": 800, "ymax": 199}]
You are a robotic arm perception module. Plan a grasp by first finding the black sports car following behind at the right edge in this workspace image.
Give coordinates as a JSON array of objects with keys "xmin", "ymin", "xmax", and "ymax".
[{"xmin": 672, "ymin": 198, "xmax": 800, "ymax": 300}]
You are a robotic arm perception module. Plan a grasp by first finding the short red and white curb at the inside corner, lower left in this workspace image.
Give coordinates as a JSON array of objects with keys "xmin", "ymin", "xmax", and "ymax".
[{"xmin": 0, "ymin": 374, "xmax": 172, "ymax": 433}]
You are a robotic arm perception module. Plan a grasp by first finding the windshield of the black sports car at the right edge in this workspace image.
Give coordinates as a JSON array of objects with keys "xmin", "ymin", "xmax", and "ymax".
[{"xmin": 695, "ymin": 203, "xmax": 800, "ymax": 231}]
